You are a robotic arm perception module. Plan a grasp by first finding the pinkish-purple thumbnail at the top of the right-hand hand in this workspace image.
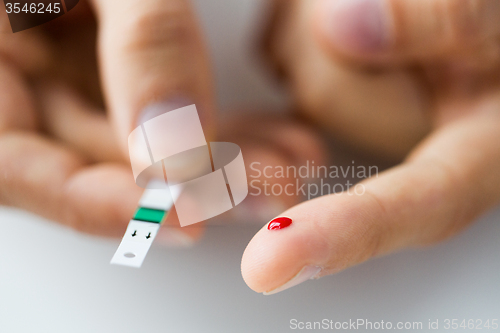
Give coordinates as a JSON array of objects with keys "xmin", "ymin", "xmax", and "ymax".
[{"xmin": 322, "ymin": 0, "xmax": 391, "ymax": 53}]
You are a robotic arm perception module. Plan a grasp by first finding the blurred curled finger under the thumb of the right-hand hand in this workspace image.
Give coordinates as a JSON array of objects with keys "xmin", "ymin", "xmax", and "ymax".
[{"xmin": 262, "ymin": 1, "xmax": 432, "ymax": 162}]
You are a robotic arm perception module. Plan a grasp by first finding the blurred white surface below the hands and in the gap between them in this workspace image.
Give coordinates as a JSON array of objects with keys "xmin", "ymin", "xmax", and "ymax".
[{"xmin": 0, "ymin": 0, "xmax": 500, "ymax": 333}]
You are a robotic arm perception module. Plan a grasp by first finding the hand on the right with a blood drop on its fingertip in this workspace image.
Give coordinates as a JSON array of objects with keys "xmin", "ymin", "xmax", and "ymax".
[{"xmin": 242, "ymin": 0, "xmax": 500, "ymax": 293}]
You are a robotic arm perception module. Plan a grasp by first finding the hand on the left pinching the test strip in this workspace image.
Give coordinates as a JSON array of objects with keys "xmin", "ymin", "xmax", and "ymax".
[{"xmin": 0, "ymin": 0, "xmax": 214, "ymax": 236}]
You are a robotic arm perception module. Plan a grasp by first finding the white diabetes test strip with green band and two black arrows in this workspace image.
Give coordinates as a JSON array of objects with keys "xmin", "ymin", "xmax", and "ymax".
[{"xmin": 111, "ymin": 180, "xmax": 179, "ymax": 268}]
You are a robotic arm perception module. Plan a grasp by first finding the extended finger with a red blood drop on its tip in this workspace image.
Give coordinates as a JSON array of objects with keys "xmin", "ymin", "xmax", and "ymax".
[{"xmin": 242, "ymin": 97, "xmax": 500, "ymax": 293}]
